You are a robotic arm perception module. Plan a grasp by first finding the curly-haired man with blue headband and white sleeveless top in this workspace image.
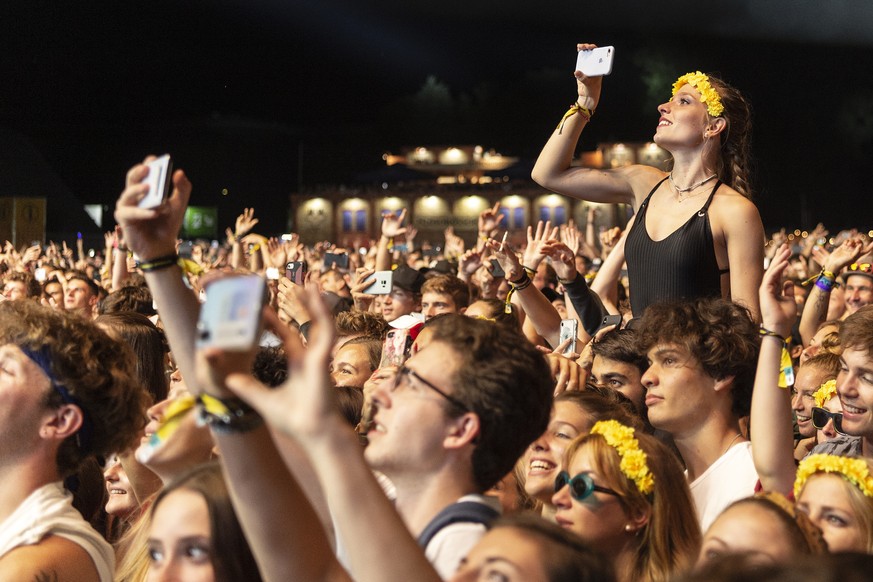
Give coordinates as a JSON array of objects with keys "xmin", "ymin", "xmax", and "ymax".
[{"xmin": 0, "ymin": 301, "xmax": 147, "ymax": 582}]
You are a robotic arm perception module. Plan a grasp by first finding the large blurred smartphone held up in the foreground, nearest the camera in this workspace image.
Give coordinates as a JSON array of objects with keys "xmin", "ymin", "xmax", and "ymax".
[{"xmin": 196, "ymin": 275, "xmax": 267, "ymax": 351}]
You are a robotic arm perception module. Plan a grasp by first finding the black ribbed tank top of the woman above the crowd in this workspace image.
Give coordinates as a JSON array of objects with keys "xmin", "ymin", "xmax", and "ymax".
[{"xmin": 624, "ymin": 178, "xmax": 727, "ymax": 317}]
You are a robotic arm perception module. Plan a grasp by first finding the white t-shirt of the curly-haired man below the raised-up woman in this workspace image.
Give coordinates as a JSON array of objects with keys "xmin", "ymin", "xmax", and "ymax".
[{"xmin": 689, "ymin": 442, "xmax": 758, "ymax": 533}]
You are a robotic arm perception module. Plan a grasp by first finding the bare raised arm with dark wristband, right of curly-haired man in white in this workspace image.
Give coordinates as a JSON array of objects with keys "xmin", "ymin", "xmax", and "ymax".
[{"xmin": 750, "ymin": 245, "xmax": 797, "ymax": 495}]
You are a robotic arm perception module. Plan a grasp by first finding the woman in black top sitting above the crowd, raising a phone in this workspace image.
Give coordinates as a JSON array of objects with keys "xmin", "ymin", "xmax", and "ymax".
[{"xmin": 532, "ymin": 44, "xmax": 764, "ymax": 319}]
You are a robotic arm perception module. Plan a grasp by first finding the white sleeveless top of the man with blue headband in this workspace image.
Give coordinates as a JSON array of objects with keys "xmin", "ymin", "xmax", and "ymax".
[{"xmin": 0, "ymin": 481, "xmax": 115, "ymax": 582}]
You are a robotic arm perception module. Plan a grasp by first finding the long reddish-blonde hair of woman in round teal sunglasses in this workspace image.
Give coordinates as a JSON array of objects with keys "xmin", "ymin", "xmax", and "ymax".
[{"xmin": 564, "ymin": 431, "xmax": 701, "ymax": 582}]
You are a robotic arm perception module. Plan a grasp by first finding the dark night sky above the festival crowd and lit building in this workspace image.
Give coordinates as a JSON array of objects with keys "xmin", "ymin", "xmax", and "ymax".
[{"xmin": 0, "ymin": 0, "xmax": 873, "ymax": 232}]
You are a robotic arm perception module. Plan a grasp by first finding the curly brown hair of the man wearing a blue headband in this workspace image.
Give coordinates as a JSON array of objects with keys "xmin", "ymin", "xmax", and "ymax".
[{"xmin": 0, "ymin": 301, "xmax": 149, "ymax": 477}]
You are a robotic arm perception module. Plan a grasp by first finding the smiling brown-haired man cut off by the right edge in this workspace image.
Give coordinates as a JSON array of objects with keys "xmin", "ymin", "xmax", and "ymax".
[{"xmin": 811, "ymin": 305, "xmax": 873, "ymax": 457}]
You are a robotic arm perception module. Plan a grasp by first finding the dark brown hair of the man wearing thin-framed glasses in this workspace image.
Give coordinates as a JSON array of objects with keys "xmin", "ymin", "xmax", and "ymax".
[{"xmin": 429, "ymin": 314, "xmax": 554, "ymax": 491}]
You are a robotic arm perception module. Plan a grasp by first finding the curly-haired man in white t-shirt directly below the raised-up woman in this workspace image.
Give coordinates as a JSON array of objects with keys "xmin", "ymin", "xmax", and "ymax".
[{"xmin": 638, "ymin": 298, "xmax": 760, "ymax": 531}]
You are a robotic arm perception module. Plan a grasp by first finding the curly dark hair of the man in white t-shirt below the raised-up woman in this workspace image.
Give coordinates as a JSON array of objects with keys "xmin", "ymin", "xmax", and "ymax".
[{"xmin": 637, "ymin": 297, "xmax": 761, "ymax": 417}]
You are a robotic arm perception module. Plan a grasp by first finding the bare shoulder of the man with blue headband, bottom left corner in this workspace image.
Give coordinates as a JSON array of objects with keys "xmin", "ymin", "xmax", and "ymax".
[{"xmin": 0, "ymin": 536, "xmax": 100, "ymax": 582}]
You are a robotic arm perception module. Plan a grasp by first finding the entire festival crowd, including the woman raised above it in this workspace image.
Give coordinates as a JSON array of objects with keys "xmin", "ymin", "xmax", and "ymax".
[{"xmin": 0, "ymin": 52, "xmax": 873, "ymax": 582}]
